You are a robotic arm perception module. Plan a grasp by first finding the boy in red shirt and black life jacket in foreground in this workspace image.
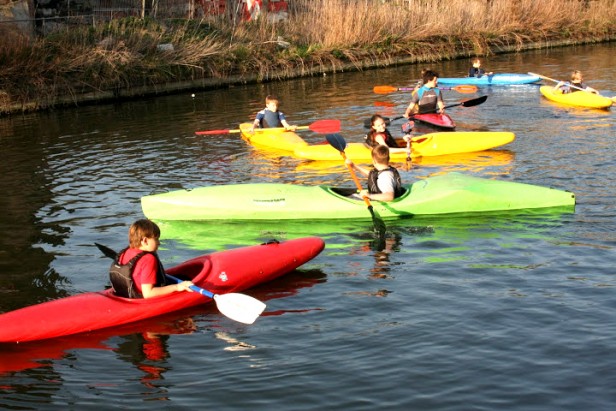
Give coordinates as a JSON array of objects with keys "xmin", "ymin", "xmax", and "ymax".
[{"xmin": 109, "ymin": 219, "xmax": 193, "ymax": 298}]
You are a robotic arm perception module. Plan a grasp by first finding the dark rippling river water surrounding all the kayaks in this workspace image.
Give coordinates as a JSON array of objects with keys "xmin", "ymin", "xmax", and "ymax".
[{"xmin": 0, "ymin": 43, "xmax": 616, "ymax": 410}]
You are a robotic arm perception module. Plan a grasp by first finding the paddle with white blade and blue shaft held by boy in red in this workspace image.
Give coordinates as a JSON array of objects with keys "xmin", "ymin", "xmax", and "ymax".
[{"xmin": 94, "ymin": 243, "xmax": 265, "ymax": 324}]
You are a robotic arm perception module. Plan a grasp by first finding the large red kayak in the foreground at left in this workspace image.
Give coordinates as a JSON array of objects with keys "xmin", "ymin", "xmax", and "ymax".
[{"xmin": 0, "ymin": 237, "xmax": 325, "ymax": 343}]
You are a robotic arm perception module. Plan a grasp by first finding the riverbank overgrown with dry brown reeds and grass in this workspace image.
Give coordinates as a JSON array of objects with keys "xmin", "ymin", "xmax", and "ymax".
[{"xmin": 0, "ymin": 0, "xmax": 616, "ymax": 114}]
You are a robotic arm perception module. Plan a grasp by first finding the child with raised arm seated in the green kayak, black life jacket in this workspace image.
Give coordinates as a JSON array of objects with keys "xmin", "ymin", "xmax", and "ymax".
[{"xmin": 346, "ymin": 145, "xmax": 405, "ymax": 201}]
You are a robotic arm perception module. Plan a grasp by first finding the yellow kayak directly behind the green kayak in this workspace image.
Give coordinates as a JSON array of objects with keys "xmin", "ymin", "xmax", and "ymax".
[{"xmin": 294, "ymin": 131, "xmax": 515, "ymax": 161}]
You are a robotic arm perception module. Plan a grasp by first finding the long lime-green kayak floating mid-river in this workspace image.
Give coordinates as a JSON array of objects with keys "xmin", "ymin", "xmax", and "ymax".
[{"xmin": 141, "ymin": 173, "xmax": 575, "ymax": 221}]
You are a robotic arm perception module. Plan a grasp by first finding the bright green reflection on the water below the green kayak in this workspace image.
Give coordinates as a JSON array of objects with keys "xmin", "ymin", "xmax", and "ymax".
[{"xmin": 157, "ymin": 207, "xmax": 572, "ymax": 253}]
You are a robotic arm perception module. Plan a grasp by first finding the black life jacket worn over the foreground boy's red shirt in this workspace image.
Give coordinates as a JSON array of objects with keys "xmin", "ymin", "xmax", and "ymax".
[{"xmin": 109, "ymin": 248, "xmax": 167, "ymax": 298}]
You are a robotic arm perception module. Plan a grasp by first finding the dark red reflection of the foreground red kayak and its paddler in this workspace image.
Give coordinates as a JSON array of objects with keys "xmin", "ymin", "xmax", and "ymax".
[{"xmin": 0, "ymin": 270, "xmax": 326, "ymax": 378}]
